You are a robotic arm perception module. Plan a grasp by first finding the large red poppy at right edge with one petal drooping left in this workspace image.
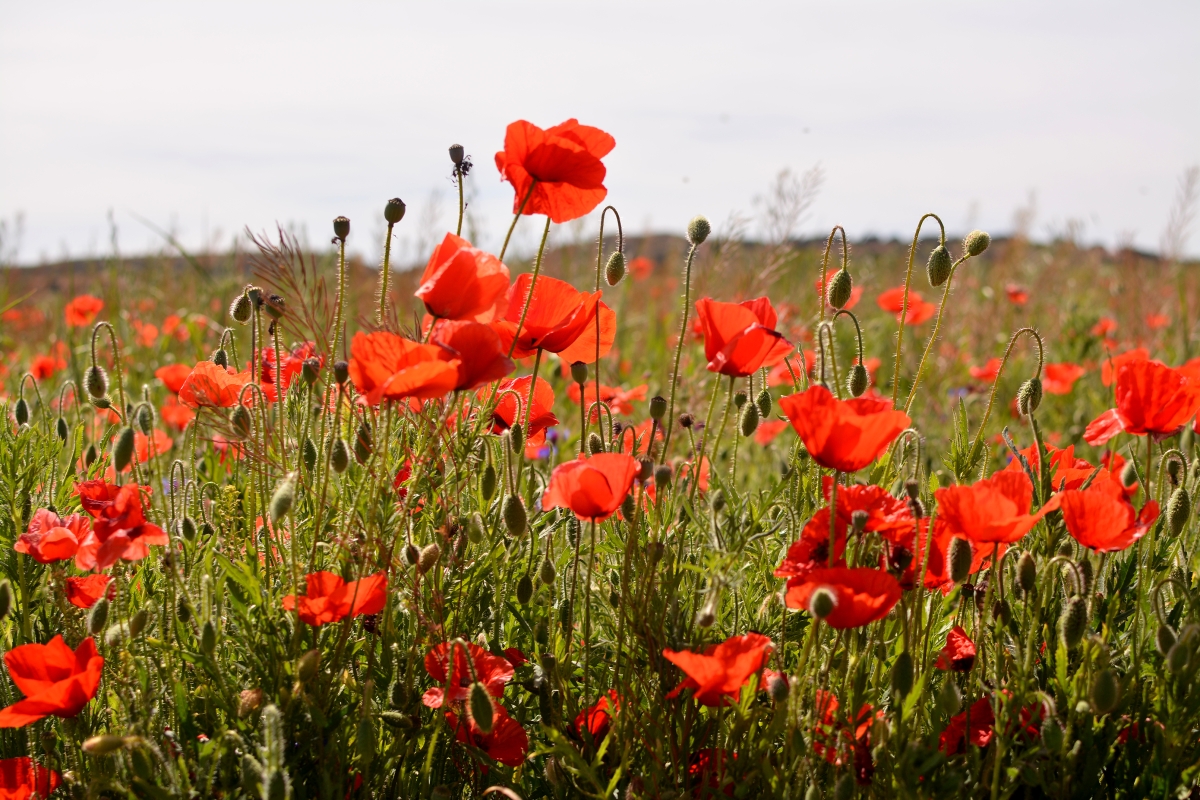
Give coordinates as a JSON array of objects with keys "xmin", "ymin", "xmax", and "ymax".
[{"xmin": 1084, "ymin": 361, "xmax": 1200, "ymax": 447}]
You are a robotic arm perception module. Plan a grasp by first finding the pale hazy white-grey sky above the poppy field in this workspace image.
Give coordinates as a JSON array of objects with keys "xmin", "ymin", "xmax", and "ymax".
[{"xmin": 0, "ymin": 0, "xmax": 1200, "ymax": 263}]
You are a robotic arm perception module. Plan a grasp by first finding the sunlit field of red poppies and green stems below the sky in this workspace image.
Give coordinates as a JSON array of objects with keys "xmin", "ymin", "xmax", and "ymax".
[{"xmin": 0, "ymin": 120, "xmax": 1200, "ymax": 800}]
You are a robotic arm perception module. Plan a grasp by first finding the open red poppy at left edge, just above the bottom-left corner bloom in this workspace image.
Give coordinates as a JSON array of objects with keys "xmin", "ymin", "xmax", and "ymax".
[{"xmin": 0, "ymin": 636, "xmax": 104, "ymax": 728}]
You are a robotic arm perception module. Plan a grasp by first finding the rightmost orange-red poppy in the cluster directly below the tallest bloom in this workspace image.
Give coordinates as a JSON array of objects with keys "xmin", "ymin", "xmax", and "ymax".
[{"xmin": 492, "ymin": 272, "xmax": 617, "ymax": 363}]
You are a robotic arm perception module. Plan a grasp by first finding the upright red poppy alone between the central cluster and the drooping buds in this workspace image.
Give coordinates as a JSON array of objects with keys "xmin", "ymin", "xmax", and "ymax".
[{"xmin": 696, "ymin": 297, "xmax": 792, "ymax": 378}]
